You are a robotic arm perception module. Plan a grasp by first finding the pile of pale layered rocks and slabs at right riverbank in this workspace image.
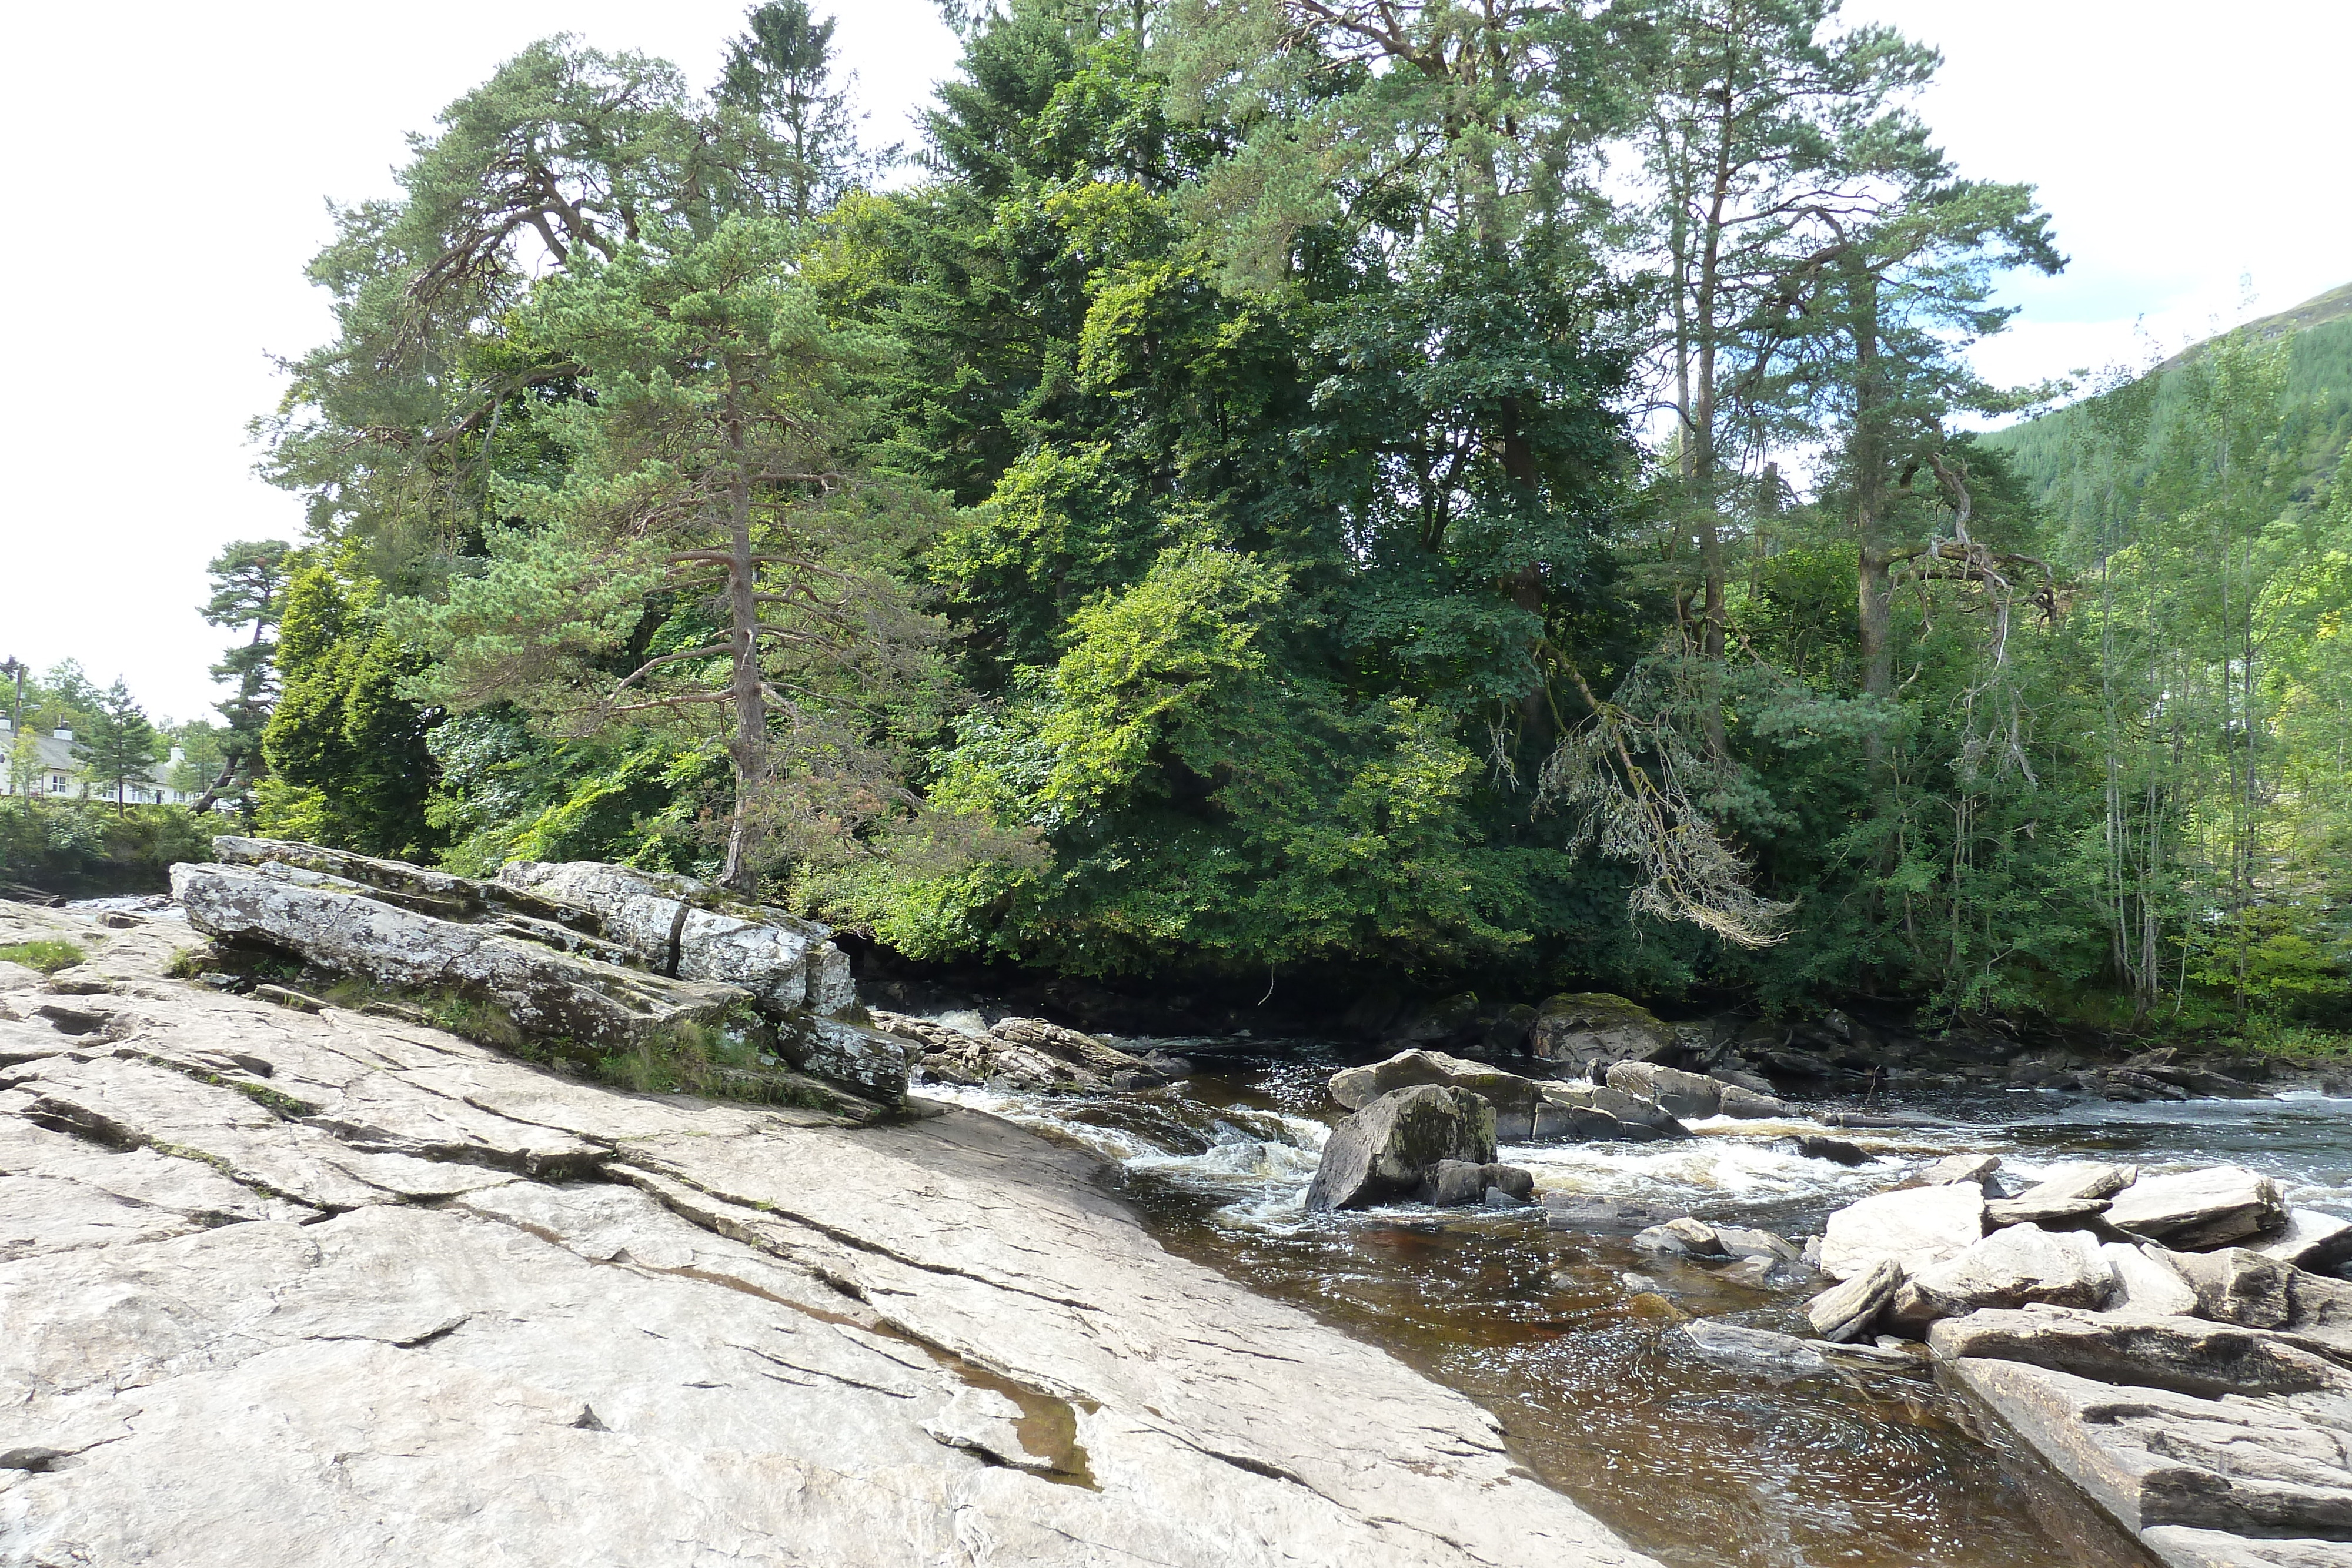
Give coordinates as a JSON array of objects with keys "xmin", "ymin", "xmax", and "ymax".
[{"xmin": 1806, "ymin": 1159, "xmax": 2352, "ymax": 1568}]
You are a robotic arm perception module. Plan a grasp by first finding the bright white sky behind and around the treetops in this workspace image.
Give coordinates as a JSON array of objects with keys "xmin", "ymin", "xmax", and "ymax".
[{"xmin": 0, "ymin": 0, "xmax": 2352, "ymax": 717}]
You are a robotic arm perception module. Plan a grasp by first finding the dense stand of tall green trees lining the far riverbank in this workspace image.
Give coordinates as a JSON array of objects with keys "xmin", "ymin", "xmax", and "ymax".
[{"xmin": 41, "ymin": 0, "xmax": 2352, "ymax": 1037}]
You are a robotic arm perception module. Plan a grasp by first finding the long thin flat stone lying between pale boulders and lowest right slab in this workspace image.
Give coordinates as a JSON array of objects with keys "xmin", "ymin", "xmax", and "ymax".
[{"xmin": 1926, "ymin": 1307, "xmax": 2352, "ymax": 1399}]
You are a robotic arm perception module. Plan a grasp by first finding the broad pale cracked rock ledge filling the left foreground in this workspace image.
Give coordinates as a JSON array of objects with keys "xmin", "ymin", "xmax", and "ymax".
[{"xmin": 0, "ymin": 902, "xmax": 1649, "ymax": 1568}]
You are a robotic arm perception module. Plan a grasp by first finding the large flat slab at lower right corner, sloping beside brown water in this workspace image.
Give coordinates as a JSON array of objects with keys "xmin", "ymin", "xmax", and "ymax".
[{"xmin": 1950, "ymin": 1359, "xmax": 2352, "ymax": 1544}]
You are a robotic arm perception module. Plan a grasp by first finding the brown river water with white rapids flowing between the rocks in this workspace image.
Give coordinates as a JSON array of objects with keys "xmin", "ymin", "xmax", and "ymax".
[{"xmin": 922, "ymin": 1039, "xmax": 2352, "ymax": 1568}]
